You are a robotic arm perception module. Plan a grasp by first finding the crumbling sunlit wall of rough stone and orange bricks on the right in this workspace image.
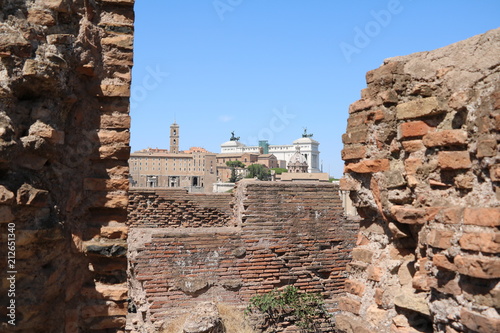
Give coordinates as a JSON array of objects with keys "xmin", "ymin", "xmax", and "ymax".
[{"xmin": 337, "ymin": 29, "xmax": 500, "ymax": 333}]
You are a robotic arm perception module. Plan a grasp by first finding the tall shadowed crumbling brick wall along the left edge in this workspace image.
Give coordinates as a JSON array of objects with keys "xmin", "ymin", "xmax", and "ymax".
[{"xmin": 0, "ymin": 0, "xmax": 134, "ymax": 333}]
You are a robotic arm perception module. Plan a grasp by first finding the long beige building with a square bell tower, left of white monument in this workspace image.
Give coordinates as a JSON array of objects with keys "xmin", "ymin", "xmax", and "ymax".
[{"xmin": 129, "ymin": 122, "xmax": 217, "ymax": 192}]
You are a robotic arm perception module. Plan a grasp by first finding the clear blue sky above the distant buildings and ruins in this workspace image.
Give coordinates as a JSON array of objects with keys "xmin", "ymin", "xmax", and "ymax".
[{"xmin": 131, "ymin": 0, "xmax": 500, "ymax": 177}]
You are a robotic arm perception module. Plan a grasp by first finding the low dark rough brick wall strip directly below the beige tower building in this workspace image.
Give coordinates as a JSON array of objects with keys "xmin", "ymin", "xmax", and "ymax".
[{"xmin": 127, "ymin": 188, "xmax": 234, "ymax": 228}]
